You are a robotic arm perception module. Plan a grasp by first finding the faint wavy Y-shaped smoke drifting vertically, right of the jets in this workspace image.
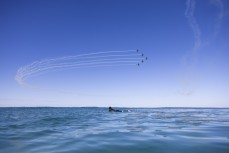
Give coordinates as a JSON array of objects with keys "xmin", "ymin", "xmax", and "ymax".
[{"xmin": 181, "ymin": 0, "xmax": 224, "ymax": 95}]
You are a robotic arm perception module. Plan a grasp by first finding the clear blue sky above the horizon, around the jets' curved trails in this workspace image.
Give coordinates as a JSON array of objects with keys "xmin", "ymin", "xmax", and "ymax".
[{"xmin": 0, "ymin": 0, "xmax": 229, "ymax": 107}]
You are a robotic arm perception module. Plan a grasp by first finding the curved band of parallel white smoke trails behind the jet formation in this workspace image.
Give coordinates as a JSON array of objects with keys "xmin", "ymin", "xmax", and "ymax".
[{"xmin": 15, "ymin": 50, "xmax": 143, "ymax": 85}]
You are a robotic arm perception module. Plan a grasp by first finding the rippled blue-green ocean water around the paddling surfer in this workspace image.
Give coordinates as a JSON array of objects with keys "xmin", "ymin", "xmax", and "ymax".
[{"xmin": 0, "ymin": 108, "xmax": 229, "ymax": 153}]
